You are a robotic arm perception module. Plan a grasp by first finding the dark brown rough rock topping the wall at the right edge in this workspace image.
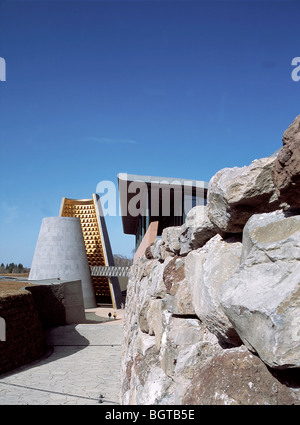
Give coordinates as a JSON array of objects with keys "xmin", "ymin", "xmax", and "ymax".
[{"xmin": 272, "ymin": 115, "xmax": 300, "ymax": 207}]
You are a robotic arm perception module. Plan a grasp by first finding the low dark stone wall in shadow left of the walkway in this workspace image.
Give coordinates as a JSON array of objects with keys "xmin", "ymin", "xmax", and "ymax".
[{"xmin": 0, "ymin": 280, "xmax": 85, "ymax": 374}]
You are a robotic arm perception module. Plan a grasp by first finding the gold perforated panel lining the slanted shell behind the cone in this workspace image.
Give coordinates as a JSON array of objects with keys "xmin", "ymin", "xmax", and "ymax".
[{"xmin": 60, "ymin": 198, "xmax": 112, "ymax": 304}]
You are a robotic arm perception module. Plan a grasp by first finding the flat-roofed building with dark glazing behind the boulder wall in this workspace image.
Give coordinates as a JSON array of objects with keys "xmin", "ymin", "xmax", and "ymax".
[{"xmin": 118, "ymin": 173, "xmax": 208, "ymax": 261}]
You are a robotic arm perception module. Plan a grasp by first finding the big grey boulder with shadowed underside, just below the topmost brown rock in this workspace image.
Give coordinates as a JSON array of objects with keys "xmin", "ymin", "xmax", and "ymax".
[{"xmin": 207, "ymin": 157, "xmax": 279, "ymax": 233}]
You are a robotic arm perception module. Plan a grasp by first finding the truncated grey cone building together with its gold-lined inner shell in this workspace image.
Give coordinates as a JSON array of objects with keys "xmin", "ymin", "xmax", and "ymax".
[{"xmin": 29, "ymin": 194, "xmax": 122, "ymax": 308}]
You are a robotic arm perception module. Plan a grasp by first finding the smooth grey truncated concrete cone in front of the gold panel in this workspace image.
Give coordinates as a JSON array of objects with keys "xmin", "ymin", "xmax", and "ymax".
[{"xmin": 28, "ymin": 217, "xmax": 97, "ymax": 308}]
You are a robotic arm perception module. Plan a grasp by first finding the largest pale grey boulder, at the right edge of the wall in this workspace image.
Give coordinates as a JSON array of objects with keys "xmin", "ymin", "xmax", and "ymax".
[{"xmin": 220, "ymin": 212, "xmax": 300, "ymax": 368}]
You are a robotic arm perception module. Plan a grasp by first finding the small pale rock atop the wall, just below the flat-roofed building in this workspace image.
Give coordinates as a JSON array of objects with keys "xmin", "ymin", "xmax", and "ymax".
[{"xmin": 179, "ymin": 205, "xmax": 221, "ymax": 255}]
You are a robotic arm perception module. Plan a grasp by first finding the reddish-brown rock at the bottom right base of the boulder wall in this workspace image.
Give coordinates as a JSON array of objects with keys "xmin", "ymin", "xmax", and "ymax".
[{"xmin": 182, "ymin": 347, "xmax": 300, "ymax": 405}]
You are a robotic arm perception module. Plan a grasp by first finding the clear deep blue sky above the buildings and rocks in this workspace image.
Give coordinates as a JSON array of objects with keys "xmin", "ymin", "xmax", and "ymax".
[{"xmin": 0, "ymin": 0, "xmax": 300, "ymax": 266}]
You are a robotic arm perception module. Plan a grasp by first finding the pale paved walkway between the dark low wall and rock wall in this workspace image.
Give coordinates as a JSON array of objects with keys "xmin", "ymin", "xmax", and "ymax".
[{"xmin": 0, "ymin": 308, "xmax": 124, "ymax": 405}]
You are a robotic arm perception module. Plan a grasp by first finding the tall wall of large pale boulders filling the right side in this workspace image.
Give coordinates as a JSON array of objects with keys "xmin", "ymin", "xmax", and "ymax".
[{"xmin": 121, "ymin": 116, "xmax": 300, "ymax": 405}]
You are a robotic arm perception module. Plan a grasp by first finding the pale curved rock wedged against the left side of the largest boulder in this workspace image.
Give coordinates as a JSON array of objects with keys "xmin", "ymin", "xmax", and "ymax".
[{"xmin": 185, "ymin": 235, "xmax": 242, "ymax": 345}]
